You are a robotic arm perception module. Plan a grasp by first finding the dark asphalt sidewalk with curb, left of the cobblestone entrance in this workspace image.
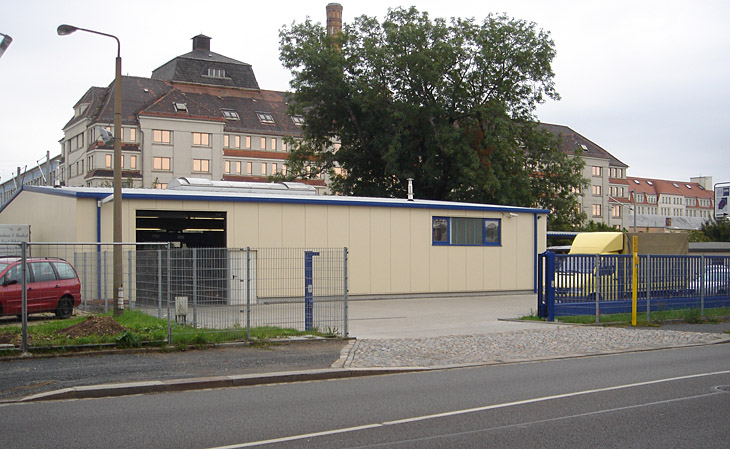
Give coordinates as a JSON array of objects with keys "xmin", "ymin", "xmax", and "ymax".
[{"xmin": 0, "ymin": 340, "xmax": 346, "ymax": 401}]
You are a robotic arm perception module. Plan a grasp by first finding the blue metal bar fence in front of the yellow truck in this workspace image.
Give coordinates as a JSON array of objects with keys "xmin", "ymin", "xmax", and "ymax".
[{"xmin": 538, "ymin": 252, "xmax": 730, "ymax": 321}]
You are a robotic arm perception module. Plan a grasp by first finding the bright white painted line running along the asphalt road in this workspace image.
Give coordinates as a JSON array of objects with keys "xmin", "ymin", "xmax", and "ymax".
[{"xmin": 209, "ymin": 370, "xmax": 730, "ymax": 449}]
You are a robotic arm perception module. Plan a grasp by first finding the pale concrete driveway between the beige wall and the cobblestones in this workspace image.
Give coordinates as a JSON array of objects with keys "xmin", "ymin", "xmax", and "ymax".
[{"xmin": 349, "ymin": 294, "xmax": 551, "ymax": 339}]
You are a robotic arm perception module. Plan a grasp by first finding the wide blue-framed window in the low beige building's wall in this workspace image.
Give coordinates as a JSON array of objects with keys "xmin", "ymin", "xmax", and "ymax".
[{"xmin": 431, "ymin": 217, "xmax": 502, "ymax": 246}]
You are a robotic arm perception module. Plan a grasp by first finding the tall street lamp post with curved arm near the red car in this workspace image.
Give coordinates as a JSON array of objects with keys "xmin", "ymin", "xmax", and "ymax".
[{"xmin": 56, "ymin": 25, "xmax": 124, "ymax": 315}]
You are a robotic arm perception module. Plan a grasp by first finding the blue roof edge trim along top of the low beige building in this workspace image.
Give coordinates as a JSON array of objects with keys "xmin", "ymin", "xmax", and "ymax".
[{"xmin": 19, "ymin": 186, "xmax": 550, "ymax": 214}]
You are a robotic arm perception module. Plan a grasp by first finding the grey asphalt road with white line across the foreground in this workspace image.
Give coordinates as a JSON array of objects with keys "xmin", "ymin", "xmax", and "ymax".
[{"xmin": 0, "ymin": 345, "xmax": 730, "ymax": 448}]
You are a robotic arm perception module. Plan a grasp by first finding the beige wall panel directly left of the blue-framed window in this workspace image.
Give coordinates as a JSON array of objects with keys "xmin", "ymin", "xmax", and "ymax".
[{"xmin": 408, "ymin": 209, "xmax": 431, "ymax": 293}]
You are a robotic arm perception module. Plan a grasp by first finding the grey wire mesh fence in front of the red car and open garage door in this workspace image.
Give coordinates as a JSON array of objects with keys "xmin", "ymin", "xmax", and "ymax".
[{"xmin": 0, "ymin": 243, "xmax": 347, "ymax": 350}]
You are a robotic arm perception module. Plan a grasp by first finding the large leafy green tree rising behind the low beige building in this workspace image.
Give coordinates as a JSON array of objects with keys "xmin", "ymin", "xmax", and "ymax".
[{"xmin": 280, "ymin": 8, "xmax": 584, "ymax": 228}]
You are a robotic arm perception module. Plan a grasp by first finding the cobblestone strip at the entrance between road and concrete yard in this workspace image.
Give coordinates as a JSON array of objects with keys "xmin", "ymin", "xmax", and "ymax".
[{"xmin": 340, "ymin": 326, "xmax": 730, "ymax": 368}]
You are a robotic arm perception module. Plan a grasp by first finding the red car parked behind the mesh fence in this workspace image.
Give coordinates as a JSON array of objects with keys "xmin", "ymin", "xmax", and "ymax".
[{"xmin": 0, "ymin": 257, "xmax": 81, "ymax": 319}]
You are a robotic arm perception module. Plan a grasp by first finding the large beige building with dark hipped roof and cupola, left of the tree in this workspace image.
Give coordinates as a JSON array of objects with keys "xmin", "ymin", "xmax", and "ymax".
[{"xmin": 57, "ymin": 35, "xmax": 326, "ymax": 191}]
